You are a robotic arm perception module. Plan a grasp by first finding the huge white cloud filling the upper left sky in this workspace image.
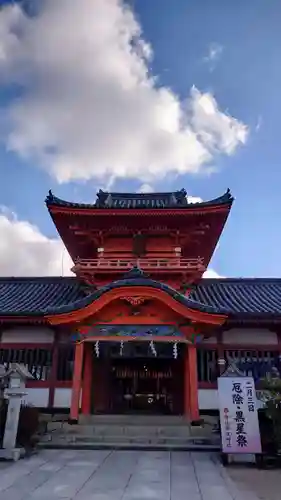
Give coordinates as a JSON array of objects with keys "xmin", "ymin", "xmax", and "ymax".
[{"xmin": 0, "ymin": 0, "xmax": 247, "ymax": 183}]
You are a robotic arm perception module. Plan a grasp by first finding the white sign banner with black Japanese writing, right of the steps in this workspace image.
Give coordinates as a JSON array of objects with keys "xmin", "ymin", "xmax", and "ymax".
[{"xmin": 218, "ymin": 376, "xmax": 261, "ymax": 453}]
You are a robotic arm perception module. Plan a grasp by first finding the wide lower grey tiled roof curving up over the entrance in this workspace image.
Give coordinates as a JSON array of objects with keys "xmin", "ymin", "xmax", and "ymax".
[{"xmin": 0, "ymin": 277, "xmax": 281, "ymax": 320}]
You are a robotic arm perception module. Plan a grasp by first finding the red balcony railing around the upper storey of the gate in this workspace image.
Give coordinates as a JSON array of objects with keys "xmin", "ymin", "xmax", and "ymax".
[{"xmin": 73, "ymin": 257, "xmax": 205, "ymax": 272}]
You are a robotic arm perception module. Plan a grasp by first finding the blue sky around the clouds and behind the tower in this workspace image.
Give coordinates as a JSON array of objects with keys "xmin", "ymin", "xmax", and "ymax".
[{"xmin": 0, "ymin": 0, "xmax": 281, "ymax": 277}]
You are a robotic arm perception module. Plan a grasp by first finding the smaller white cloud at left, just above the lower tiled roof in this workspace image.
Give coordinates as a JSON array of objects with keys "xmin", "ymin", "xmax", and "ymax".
[{"xmin": 0, "ymin": 207, "xmax": 73, "ymax": 276}]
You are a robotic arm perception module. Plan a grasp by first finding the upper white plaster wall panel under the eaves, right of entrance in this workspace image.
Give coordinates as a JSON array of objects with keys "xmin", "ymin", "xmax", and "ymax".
[{"xmin": 222, "ymin": 328, "xmax": 278, "ymax": 345}]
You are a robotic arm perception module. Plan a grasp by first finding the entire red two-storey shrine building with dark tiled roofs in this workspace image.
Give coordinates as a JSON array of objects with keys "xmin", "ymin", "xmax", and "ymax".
[{"xmin": 0, "ymin": 189, "xmax": 281, "ymax": 422}]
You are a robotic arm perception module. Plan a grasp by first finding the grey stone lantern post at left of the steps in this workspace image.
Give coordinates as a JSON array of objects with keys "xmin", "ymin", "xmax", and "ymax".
[{"xmin": 0, "ymin": 363, "xmax": 33, "ymax": 460}]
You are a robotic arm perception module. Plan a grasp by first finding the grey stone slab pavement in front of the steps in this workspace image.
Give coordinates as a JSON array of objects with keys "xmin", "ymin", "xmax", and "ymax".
[{"xmin": 0, "ymin": 450, "xmax": 257, "ymax": 500}]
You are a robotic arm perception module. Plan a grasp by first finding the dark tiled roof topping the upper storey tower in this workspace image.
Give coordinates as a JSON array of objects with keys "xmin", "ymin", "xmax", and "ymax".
[{"xmin": 46, "ymin": 189, "xmax": 233, "ymax": 209}]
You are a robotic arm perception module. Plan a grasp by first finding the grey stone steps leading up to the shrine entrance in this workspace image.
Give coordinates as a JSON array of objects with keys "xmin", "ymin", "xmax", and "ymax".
[{"xmin": 39, "ymin": 415, "xmax": 217, "ymax": 451}]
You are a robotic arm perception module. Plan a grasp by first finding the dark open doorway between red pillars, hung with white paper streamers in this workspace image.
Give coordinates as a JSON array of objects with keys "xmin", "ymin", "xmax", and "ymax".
[{"xmin": 89, "ymin": 340, "xmax": 186, "ymax": 415}]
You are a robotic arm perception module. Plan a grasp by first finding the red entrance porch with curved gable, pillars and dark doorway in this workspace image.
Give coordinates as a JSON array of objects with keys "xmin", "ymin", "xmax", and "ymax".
[{"xmin": 48, "ymin": 282, "xmax": 226, "ymax": 422}]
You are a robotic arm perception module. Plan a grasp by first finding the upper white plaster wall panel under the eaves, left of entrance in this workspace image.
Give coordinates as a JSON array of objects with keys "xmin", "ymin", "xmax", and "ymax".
[{"xmin": 1, "ymin": 326, "xmax": 54, "ymax": 344}]
